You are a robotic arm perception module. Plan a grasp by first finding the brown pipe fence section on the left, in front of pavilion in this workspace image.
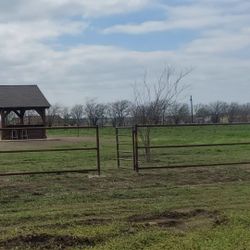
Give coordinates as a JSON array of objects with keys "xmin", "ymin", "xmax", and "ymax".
[{"xmin": 0, "ymin": 126, "xmax": 101, "ymax": 176}]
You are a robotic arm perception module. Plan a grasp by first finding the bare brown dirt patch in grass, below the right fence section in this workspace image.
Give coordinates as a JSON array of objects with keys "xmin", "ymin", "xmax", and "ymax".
[{"xmin": 128, "ymin": 209, "xmax": 227, "ymax": 229}]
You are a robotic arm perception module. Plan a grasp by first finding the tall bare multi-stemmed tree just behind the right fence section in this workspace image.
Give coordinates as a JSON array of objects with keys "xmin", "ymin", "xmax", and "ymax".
[{"xmin": 132, "ymin": 66, "xmax": 191, "ymax": 161}]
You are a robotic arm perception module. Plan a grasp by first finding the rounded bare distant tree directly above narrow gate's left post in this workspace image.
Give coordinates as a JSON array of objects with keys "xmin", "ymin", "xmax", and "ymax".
[{"xmin": 107, "ymin": 100, "xmax": 131, "ymax": 127}]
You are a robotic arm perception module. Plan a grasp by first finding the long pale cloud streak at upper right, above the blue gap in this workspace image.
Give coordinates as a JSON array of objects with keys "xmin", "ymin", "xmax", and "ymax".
[{"xmin": 103, "ymin": 1, "xmax": 250, "ymax": 34}]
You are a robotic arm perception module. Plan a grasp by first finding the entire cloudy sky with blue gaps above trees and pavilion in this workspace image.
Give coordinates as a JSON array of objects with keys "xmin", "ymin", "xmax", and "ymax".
[{"xmin": 0, "ymin": 0, "xmax": 250, "ymax": 105}]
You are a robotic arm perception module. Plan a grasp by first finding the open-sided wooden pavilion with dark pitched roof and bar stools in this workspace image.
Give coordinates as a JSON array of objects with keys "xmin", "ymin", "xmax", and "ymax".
[{"xmin": 0, "ymin": 85, "xmax": 50, "ymax": 140}]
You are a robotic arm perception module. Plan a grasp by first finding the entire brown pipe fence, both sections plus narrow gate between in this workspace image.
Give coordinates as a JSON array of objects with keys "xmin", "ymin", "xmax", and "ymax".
[{"xmin": 0, "ymin": 123, "xmax": 250, "ymax": 176}]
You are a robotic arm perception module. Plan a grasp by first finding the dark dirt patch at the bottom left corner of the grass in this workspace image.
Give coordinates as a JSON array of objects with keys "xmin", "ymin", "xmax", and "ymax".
[{"xmin": 0, "ymin": 234, "xmax": 95, "ymax": 249}]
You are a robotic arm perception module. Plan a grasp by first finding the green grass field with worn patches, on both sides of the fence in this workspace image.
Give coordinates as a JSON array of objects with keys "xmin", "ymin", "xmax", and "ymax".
[{"xmin": 0, "ymin": 125, "xmax": 250, "ymax": 250}]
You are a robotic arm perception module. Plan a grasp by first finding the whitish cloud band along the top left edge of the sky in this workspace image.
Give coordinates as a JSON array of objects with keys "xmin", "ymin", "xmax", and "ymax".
[{"xmin": 0, "ymin": 0, "xmax": 151, "ymax": 21}]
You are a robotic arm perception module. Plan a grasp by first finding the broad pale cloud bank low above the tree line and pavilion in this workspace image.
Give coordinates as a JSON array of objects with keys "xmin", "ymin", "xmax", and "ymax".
[{"xmin": 0, "ymin": 38, "xmax": 250, "ymax": 105}]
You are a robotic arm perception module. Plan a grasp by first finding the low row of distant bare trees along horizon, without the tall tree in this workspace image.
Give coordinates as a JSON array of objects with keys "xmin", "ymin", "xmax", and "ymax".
[{"xmin": 47, "ymin": 100, "xmax": 250, "ymax": 127}]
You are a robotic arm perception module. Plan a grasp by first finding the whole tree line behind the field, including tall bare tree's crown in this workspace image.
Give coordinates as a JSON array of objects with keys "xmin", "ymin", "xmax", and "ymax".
[{"xmin": 47, "ymin": 65, "xmax": 250, "ymax": 127}]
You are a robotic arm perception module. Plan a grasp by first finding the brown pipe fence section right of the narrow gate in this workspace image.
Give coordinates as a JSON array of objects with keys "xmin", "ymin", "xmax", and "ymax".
[{"xmin": 132, "ymin": 123, "xmax": 250, "ymax": 172}]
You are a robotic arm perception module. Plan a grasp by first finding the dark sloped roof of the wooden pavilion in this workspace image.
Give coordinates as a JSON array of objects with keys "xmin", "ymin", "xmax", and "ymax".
[{"xmin": 0, "ymin": 85, "xmax": 50, "ymax": 109}]
